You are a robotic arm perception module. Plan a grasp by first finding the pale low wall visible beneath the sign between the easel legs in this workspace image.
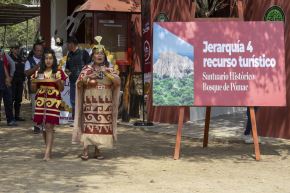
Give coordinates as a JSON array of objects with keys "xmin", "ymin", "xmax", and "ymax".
[{"xmin": 190, "ymin": 107, "xmax": 246, "ymax": 121}]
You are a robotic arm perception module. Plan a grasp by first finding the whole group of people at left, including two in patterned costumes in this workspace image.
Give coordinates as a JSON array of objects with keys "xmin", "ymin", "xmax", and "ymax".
[{"xmin": 0, "ymin": 36, "xmax": 120, "ymax": 161}]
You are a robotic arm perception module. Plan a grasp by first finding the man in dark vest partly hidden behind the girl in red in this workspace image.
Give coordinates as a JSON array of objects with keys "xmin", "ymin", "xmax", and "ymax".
[{"xmin": 24, "ymin": 43, "xmax": 43, "ymax": 134}]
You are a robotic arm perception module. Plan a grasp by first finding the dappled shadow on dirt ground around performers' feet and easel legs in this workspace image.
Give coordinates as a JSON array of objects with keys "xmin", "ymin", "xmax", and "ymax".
[{"xmin": 0, "ymin": 103, "xmax": 290, "ymax": 192}]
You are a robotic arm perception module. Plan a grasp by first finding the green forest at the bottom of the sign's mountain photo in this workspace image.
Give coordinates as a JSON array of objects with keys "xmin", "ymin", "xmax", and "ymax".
[{"xmin": 153, "ymin": 74, "xmax": 194, "ymax": 106}]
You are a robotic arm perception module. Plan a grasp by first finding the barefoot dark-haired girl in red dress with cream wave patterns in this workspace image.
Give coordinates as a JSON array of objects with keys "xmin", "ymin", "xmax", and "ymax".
[{"xmin": 31, "ymin": 50, "xmax": 66, "ymax": 161}]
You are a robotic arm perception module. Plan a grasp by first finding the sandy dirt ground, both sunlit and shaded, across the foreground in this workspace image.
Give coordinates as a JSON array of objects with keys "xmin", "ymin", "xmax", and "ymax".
[{"xmin": 0, "ymin": 105, "xmax": 290, "ymax": 193}]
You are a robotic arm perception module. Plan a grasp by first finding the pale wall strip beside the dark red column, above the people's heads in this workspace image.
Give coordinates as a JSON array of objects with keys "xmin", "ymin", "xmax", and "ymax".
[{"xmin": 50, "ymin": 0, "xmax": 68, "ymax": 42}]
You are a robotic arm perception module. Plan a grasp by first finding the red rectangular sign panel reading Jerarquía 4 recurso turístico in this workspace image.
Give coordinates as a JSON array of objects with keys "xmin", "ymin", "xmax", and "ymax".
[{"xmin": 153, "ymin": 21, "xmax": 286, "ymax": 106}]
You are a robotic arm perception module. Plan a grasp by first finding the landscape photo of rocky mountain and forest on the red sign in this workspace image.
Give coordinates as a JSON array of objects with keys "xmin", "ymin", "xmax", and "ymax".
[{"xmin": 153, "ymin": 24, "xmax": 194, "ymax": 106}]
